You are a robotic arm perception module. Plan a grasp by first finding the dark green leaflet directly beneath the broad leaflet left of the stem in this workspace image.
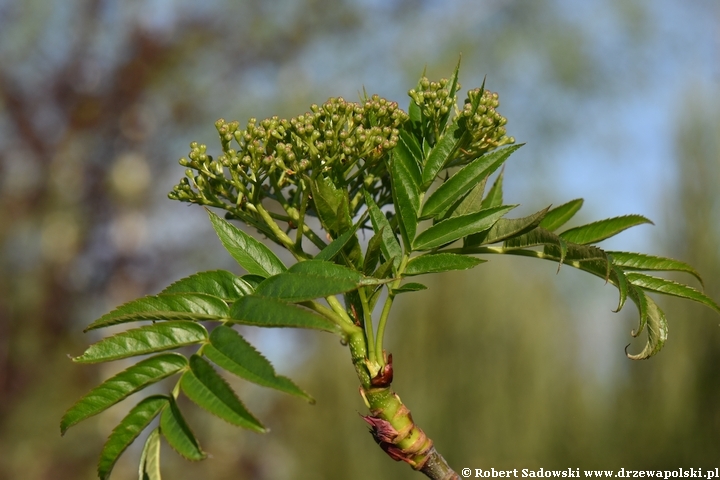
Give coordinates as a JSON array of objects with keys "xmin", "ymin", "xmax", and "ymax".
[{"xmin": 229, "ymin": 295, "xmax": 338, "ymax": 332}]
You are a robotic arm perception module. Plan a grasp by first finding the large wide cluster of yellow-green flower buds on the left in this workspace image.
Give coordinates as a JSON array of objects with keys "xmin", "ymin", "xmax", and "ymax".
[{"xmin": 170, "ymin": 95, "xmax": 407, "ymax": 212}]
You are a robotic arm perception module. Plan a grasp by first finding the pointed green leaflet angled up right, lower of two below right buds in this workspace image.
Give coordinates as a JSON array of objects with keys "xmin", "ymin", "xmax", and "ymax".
[{"xmin": 413, "ymin": 205, "xmax": 517, "ymax": 250}]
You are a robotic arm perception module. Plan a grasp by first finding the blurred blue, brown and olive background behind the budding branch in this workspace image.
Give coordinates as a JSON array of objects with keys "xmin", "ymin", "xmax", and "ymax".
[{"xmin": 0, "ymin": 0, "xmax": 720, "ymax": 480}]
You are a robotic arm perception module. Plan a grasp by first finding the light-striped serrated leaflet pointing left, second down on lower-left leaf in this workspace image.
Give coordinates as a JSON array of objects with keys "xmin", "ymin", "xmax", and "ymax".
[{"xmin": 73, "ymin": 322, "xmax": 208, "ymax": 363}]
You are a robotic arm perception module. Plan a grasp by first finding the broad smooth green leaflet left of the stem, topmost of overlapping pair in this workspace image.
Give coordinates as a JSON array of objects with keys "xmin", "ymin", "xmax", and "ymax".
[{"xmin": 255, "ymin": 260, "xmax": 378, "ymax": 303}]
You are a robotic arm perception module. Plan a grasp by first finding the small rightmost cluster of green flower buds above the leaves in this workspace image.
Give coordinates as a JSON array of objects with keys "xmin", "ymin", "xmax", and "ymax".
[{"xmin": 458, "ymin": 88, "xmax": 515, "ymax": 163}]
